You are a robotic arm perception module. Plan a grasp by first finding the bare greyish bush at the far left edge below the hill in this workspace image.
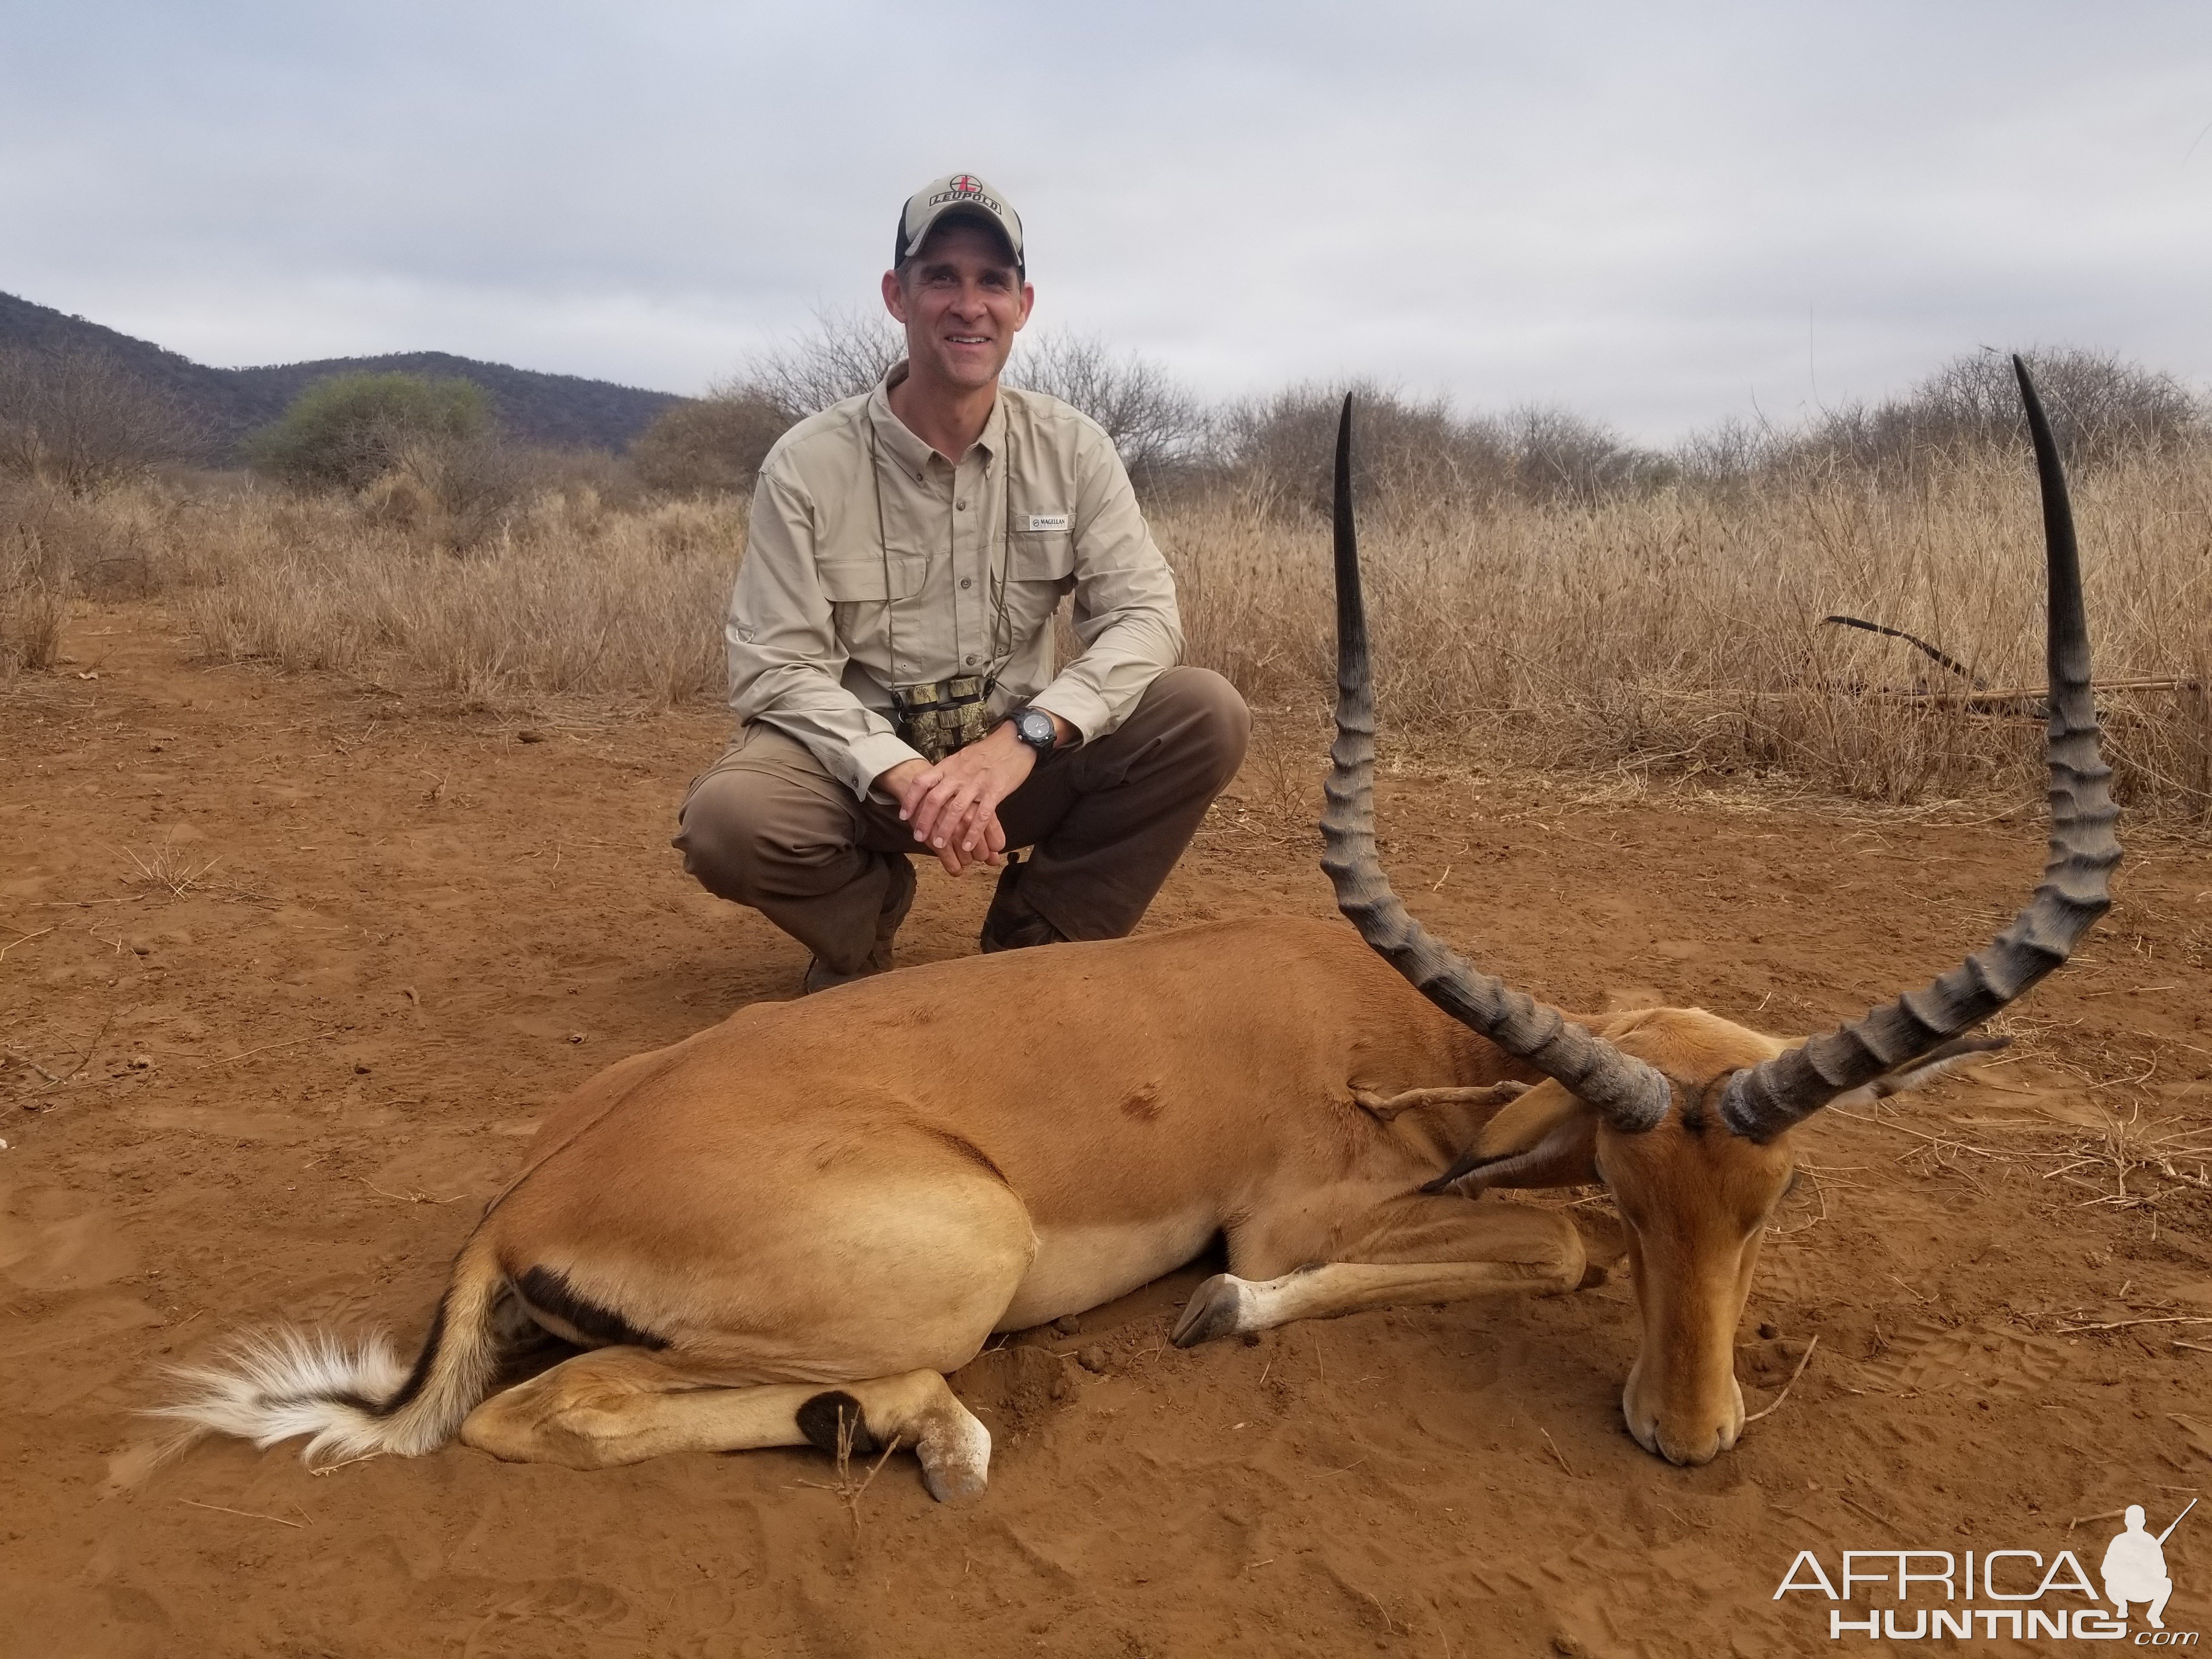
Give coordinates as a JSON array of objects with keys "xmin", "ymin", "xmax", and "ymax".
[{"xmin": 0, "ymin": 345, "xmax": 208, "ymax": 495}]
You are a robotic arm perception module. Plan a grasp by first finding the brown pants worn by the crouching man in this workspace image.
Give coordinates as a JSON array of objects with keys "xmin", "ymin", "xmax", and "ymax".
[{"xmin": 675, "ymin": 668, "xmax": 1252, "ymax": 973}]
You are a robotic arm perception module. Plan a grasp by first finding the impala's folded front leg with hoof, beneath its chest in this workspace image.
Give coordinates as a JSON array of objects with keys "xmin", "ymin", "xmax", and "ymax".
[{"xmin": 1170, "ymin": 1197, "xmax": 1588, "ymax": 1347}]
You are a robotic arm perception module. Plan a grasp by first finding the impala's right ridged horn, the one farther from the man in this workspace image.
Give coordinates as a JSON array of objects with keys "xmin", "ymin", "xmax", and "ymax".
[{"xmin": 1721, "ymin": 356, "xmax": 2119, "ymax": 1142}]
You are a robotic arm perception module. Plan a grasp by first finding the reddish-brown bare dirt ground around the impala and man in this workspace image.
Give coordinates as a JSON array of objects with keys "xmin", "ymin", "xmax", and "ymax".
[{"xmin": 0, "ymin": 608, "xmax": 2212, "ymax": 1659}]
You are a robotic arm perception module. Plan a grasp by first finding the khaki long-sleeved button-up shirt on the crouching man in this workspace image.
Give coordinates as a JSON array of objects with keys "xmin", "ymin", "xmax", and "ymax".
[{"xmin": 725, "ymin": 363, "xmax": 1183, "ymax": 797}]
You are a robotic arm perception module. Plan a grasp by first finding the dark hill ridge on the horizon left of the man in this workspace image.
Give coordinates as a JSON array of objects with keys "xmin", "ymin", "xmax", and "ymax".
[{"xmin": 0, "ymin": 294, "xmax": 681, "ymax": 454}]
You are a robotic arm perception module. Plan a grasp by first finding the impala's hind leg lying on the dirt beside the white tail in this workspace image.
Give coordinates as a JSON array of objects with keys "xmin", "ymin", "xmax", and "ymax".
[{"xmin": 460, "ymin": 1347, "xmax": 991, "ymax": 1500}]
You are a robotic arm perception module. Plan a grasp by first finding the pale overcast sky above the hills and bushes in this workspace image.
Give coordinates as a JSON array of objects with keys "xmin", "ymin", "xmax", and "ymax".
[{"xmin": 0, "ymin": 0, "xmax": 2212, "ymax": 440}]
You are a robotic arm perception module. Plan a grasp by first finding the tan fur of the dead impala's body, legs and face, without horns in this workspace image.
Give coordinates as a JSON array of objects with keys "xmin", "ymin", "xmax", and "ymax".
[{"xmin": 184, "ymin": 918, "xmax": 1973, "ymax": 1498}]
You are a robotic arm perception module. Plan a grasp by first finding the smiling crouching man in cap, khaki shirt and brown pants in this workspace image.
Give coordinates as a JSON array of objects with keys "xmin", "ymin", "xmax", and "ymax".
[{"xmin": 675, "ymin": 172, "xmax": 1250, "ymax": 991}]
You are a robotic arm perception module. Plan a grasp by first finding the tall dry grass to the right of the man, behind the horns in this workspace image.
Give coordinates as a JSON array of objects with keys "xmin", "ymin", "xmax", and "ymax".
[{"xmin": 1157, "ymin": 456, "xmax": 2212, "ymax": 816}]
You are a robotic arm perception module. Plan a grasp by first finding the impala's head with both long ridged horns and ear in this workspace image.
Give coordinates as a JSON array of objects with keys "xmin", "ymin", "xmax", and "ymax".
[{"xmin": 1321, "ymin": 358, "xmax": 2119, "ymax": 1464}]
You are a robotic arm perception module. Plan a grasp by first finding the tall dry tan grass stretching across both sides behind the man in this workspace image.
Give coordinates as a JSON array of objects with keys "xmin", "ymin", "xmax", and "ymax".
[{"xmin": 13, "ymin": 452, "xmax": 2212, "ymax": 819}]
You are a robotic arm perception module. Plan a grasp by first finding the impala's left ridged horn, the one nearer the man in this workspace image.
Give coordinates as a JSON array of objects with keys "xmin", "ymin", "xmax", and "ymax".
[{"xmin": 1321, "ymin": 396, "xmax": 1670, "ymax": 1132}]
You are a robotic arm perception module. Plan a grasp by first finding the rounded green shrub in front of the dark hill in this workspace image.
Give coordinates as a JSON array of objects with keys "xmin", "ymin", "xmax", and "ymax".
[{"xmin": 246, "ymin": 374, "xmax": 491, "ymax": 489}]
